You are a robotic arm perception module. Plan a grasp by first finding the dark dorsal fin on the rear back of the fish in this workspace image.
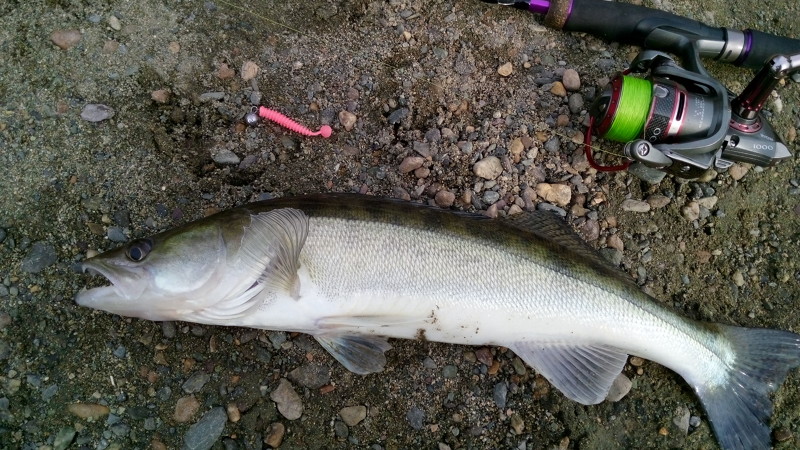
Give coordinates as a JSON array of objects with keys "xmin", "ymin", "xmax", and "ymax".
[{"xmin": 502, "ymin": 211, "xmax": 639, "ymax": 290}]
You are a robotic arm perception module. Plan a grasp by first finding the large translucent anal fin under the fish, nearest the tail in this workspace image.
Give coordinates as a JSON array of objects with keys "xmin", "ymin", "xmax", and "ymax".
[{"xmin": 510, "ymin": 342, "xmax": 628, "ymax": 405}]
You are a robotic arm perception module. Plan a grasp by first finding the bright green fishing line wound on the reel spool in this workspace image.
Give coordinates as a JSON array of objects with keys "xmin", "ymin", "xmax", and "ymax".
[{"xmin": 605, "ymin": 76, "xmax": 653, "ymax": 142}]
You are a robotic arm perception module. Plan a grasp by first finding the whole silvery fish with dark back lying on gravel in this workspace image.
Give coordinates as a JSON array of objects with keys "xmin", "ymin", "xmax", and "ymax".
[{"xmin": 75, "ymin": 194, "xmax": 800, "ymax": 449}]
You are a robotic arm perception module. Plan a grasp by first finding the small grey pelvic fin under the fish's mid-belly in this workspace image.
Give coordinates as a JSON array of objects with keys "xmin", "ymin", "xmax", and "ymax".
[{"xmin": 314, "ymin": 333, "xmax": 392, "ymax": 375}]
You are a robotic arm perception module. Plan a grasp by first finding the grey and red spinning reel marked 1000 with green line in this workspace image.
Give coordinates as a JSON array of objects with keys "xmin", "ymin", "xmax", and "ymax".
[{"xmin": 585, "ymin": 50, "xmax": 800, "ymax": 178}]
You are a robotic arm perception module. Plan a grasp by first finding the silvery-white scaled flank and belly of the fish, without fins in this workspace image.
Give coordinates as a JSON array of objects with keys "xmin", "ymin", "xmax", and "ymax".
[{"xmin": 292, "ymin": 219, "xmax": 716, "ymax": 384}]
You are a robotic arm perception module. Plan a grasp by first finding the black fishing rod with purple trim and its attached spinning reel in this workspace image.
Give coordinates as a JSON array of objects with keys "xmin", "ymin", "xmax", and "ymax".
[{"xmin": 482, "ymin": 0, "xmax": 800, "ymax": 178}]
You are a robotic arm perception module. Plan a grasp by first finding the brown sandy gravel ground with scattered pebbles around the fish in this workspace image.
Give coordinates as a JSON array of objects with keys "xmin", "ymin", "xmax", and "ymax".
[{"xmin": 0, "ymin": 0, "xmax": 800, "ymax": 449}]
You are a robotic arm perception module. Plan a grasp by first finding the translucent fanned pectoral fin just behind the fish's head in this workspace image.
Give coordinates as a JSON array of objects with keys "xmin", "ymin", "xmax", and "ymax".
[{"xmin": 239, "ymin": 208, "xmax": 308, "ymax": 298}]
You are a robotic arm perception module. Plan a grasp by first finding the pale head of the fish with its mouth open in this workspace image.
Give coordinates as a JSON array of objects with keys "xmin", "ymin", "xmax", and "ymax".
[{"xmin": 75, "ymin": 221, "xmax": 227, "ymax": 320}]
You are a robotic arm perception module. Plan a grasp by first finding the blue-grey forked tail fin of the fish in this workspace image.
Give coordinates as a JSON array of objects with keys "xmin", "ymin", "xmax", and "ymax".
[{"xmin": 694, "ymin": 325, "xmax": 800, "ymax": 450}]
